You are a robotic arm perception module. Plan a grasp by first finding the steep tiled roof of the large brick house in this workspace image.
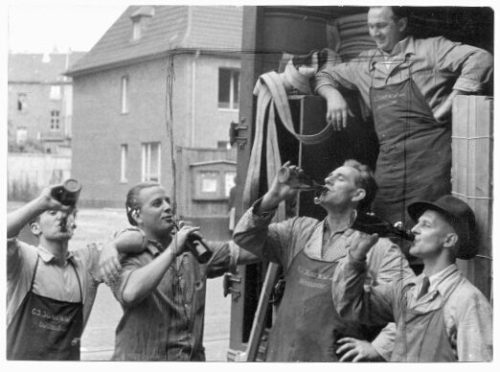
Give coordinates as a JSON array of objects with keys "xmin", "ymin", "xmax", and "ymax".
[{"xmin": 67, "ymin": 6, "xmax": 243, "ymax": 76}]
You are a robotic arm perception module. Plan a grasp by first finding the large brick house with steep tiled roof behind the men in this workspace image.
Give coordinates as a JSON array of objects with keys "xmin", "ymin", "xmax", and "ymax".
[{"xmin": 67, "ymin": 6, "xmax": 243, "ymax": 232}]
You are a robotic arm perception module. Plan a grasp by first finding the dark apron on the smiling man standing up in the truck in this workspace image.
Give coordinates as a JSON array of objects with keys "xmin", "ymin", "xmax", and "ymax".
[{"xmin": 370, "ymin": 62, "xmax": 451, "ymax": 224}]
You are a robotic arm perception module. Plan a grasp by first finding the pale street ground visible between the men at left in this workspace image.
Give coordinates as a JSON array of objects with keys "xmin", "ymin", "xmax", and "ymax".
[{"xmin": 8, "ymin": 202, "xmax": 231, "ymax": 362}]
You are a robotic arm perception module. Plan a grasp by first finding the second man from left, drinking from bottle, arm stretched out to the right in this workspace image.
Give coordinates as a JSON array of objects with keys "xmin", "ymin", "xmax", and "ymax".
[{"xmin": 102, "ymin": 182, "xmax": 257, "ymax": 361}]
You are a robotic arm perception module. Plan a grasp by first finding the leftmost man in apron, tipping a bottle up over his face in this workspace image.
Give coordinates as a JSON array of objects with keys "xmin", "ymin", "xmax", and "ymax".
[{"xmin": 7, "ymin": 185, "xmax": 126, "ymax": 360}]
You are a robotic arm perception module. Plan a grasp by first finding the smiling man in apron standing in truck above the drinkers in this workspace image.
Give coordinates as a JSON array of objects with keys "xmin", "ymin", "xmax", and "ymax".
[{"xmin": 316, "ymin": 7, "xmax": 493, "ymax": 227}]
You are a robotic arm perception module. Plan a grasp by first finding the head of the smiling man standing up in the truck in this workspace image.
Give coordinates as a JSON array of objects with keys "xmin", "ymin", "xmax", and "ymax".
[{"xmin": 368, "ymin": 6, "xmax": 408, "ymax": 53}]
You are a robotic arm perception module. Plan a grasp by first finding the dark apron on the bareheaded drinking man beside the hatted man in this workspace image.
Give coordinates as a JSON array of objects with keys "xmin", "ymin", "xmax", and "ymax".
[{"xmin": 266, "ymin": 251, "xmax": 372, "ymax": 362}]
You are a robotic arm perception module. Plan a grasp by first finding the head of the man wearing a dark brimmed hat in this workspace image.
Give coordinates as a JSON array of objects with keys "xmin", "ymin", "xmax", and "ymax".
[{"xmin": 408, "ymin": 195, "xmax": 479, "ymax": 261}]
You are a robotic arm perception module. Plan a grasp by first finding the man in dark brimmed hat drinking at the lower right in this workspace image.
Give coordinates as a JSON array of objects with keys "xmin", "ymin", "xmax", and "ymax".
[{"xmin": 332, "ymin": 195, "xmax": 493, "ymax": 362}]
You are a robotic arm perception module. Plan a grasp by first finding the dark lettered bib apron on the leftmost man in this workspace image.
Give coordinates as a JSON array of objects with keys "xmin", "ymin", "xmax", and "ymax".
[{"xmin": 7, "ymin": 256, "xmax": 83, "ymax": 360}]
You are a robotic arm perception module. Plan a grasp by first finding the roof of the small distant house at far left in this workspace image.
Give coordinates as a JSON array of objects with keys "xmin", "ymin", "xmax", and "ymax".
[{"xmin": 8, "ymin": 52, "xmax": 85, "ymax": 83}]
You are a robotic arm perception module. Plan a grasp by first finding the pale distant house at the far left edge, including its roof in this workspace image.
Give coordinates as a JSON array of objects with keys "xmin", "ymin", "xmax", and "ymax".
[{"xmin": 8, "ymin": 52, "xmax": 84, "ymax": 154}]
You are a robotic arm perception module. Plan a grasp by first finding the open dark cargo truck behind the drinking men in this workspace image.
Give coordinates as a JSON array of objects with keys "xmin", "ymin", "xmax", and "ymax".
[{"xmin": 225, "ymin": 6, "xmax": 493, "ymax": 361}]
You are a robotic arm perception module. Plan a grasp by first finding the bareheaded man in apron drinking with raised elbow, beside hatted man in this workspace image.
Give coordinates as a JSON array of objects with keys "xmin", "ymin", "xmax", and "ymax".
[{"xmin": 233, "ymin": 161, "xmax": 413, "ymax": 362}]
